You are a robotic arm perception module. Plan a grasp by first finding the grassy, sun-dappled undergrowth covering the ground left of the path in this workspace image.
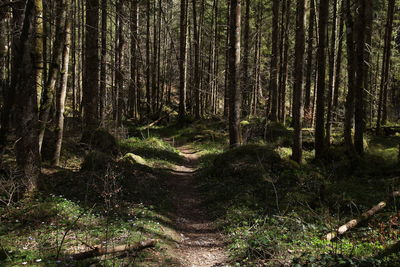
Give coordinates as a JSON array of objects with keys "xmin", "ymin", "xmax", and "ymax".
[{"xmin": 0, "ymin": 132, "xmax": 188, "ymax": 266}]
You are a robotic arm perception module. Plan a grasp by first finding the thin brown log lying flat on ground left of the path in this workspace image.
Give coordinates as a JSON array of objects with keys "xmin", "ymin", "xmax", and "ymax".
[{"xmin": 70, "ymin": 239, "xmax": 157, "ymax": 260}]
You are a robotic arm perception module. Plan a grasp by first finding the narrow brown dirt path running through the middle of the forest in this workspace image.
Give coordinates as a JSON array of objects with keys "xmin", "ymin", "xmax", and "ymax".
[{"xmin": 166, "ymin": 146, "xmax": 229, "ymax": 267}]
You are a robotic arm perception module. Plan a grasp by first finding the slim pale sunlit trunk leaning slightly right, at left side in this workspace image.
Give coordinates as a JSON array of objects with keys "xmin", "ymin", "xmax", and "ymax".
[{"xmin": 52, "ymin": 0, "xmax": 71, "ymax": 166}]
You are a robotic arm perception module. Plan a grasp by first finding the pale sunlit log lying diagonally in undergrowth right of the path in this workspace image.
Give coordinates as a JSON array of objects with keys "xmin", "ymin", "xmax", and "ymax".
[{"xmin": 325, "ymin": 191, "xmax": 400, "ymax": 241}]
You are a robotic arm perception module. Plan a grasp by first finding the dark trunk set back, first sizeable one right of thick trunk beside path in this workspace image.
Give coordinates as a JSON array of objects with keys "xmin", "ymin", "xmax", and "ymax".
[{"xmin": 269, "ymin": 0, "xmax": 280, "ymax": 121}]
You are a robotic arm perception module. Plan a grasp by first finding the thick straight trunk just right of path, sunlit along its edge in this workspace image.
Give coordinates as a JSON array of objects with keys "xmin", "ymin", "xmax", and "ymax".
[{"xmin": 228, "ymin": 0, "xmax": 241, "ymax": 147}]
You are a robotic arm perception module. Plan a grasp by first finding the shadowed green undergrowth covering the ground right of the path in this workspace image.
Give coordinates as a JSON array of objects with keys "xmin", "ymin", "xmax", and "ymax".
[{"xmin": 195, "ymin": 121, "xmax": 400, "ymax": 266}]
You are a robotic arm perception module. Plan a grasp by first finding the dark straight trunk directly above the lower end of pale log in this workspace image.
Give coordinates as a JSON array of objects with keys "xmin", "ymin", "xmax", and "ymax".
[{"xmin": 315, "ymin": 0, "xmax": 329, "ymax": 159}]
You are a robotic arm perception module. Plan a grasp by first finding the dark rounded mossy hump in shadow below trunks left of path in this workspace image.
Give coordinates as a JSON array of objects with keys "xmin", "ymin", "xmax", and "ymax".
[{"xmin": 82, "ymin": 128, "xmax": 118, "ymax": 154}]
